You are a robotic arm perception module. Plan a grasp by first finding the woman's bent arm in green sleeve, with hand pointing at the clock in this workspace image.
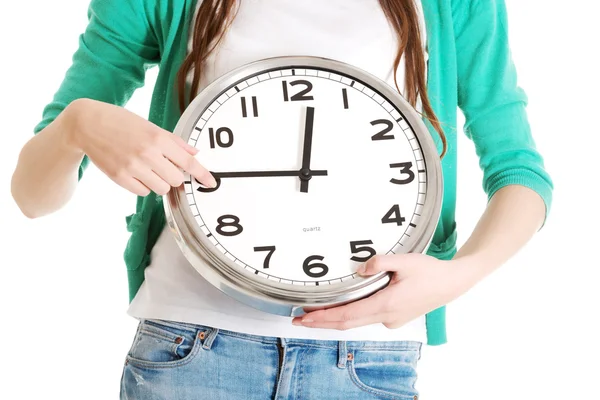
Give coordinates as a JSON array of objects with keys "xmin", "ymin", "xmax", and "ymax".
[{"xmin": 11, "ymin": 0, "xmax": 214, "ymax": 218}]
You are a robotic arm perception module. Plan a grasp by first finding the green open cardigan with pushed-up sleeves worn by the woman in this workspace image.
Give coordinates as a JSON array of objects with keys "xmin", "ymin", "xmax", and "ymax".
[{"xmin": 34, "ymin": 0, "xmax": 553, "ymax": 345}]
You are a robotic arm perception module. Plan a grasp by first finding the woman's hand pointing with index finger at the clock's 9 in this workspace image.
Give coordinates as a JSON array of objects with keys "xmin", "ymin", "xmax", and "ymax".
[{"xmin": 67, "ymin": 99, "xmax": 216, "ymax": 196}]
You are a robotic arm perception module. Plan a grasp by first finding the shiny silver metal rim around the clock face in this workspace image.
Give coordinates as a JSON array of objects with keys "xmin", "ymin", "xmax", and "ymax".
[{"xmin": 163, "ymin": 56, "xmax": 443, "ymax": 315}]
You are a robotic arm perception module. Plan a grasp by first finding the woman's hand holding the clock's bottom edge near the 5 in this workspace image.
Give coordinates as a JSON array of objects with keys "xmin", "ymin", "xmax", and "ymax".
[{"xmin": 293, "ymin": 253, "xmax": 475, "ymax": 330}]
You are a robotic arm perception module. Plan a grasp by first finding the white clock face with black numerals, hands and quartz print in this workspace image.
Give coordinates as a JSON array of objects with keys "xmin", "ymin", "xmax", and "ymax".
[{"xmin": 184, "ymin": 68, "xmax": 427, "ymax": 286}]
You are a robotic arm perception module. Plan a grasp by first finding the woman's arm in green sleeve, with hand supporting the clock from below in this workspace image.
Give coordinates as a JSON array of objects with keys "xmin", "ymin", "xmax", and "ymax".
[{"xmin": 294, "ymin": 0, "xmax": 553, "ymax": 329}]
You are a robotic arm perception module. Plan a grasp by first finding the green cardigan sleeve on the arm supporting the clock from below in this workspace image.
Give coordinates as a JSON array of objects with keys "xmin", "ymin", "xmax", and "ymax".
[{"xmin": 452, "ymin": 0, "xmax": 553, "ymax": 225}]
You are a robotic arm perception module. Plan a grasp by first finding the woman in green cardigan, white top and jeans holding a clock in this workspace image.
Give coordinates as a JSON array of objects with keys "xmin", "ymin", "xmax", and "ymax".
[{"xmin": 12, "ymin": 0, "xmax": 553, "ymax": 400}]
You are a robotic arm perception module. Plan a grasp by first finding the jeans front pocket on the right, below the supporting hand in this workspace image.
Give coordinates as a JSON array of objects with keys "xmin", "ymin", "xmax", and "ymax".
[{"xmin": 348, "ymin": 348, "xmax": 420, "ymax": 400}]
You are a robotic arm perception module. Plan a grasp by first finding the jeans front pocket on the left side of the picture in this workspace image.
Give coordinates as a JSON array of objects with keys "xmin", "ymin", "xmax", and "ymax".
[{"xmin": 126, "ymin": 320, "xmax": 205, "ymax": 368}]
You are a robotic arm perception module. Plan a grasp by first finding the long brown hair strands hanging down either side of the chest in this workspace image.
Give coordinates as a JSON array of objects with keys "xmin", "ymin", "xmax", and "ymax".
[{"xmin": 177, "ymin": 0, "xmax": 447, "ymax": 157}]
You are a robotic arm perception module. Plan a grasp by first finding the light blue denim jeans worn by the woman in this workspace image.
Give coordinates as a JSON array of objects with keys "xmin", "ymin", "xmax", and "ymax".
[{"xmin": 121, "ymin": 320, "xmax": 421, "ymax": 400}]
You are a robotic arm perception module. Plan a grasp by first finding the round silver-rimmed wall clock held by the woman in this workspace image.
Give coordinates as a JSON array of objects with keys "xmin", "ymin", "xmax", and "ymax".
[{"xmin": 164, "ymin": 57, "xmax": 443, "ymax": 316}]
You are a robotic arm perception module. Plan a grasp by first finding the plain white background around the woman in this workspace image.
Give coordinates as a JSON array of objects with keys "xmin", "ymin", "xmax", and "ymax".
[{"xmin": 0, "ymin": 0, "xmax": 600, "ymax": 400}]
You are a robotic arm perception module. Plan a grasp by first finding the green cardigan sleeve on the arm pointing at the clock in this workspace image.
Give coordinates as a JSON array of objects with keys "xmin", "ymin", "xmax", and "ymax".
[{"xmin": 34, "ymin": 0, "xmax": 159, "ymax": 179}]
